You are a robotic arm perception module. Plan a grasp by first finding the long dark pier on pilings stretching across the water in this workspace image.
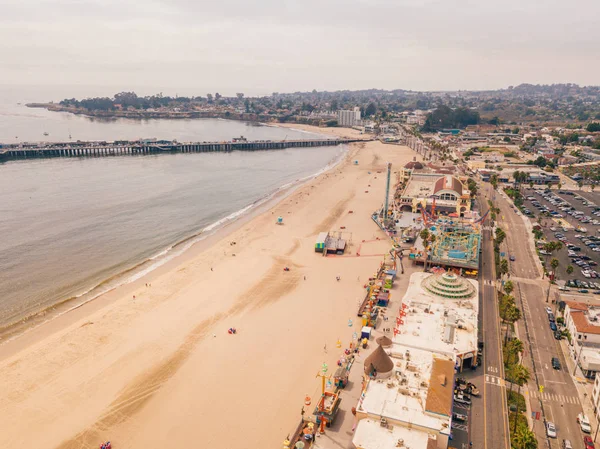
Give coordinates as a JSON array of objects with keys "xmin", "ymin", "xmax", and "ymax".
[{"xmin": 0, "ymin": 139, "xmax": 359, "ymax": 160}]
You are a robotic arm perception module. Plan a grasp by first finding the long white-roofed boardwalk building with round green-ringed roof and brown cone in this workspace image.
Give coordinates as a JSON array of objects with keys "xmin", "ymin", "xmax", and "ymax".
[{"xmin": 353, "ymin": 272, "xmax": 479, "ymax": 449}]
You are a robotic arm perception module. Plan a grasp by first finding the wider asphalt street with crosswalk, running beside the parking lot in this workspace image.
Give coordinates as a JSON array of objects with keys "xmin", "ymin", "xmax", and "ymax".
[{"xmin": 484, "ymin": 186, "xmax": 584, "ymax": 449}]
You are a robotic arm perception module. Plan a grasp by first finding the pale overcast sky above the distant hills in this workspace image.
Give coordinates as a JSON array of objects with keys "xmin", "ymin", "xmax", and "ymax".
[{"xmin": 0, "ymin": 0, "xmax": 600, "ymax": 95}]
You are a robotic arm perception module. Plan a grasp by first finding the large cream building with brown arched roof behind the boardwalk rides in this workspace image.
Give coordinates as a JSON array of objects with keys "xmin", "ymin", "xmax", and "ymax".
[{"xmin": 400, "ymin": 171, "xmax": 471, "ymax": 217}]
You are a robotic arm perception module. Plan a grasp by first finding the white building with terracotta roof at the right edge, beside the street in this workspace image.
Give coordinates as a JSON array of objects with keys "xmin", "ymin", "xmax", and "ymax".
[{"xmin": 564, "ymin": 301, "xmax": 600, "ymax": 379}]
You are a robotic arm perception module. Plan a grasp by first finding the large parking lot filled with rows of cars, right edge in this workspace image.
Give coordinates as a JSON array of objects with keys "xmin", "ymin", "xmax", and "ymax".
[{"xmin": 523, "ymin": 189, "xmax": 600, "ymax": 294}]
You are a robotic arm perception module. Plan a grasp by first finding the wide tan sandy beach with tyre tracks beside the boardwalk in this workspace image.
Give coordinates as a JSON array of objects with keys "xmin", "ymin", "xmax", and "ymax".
[{"xmin": 0, "ymin": 124, "xmax": 422, "ymax": 449}]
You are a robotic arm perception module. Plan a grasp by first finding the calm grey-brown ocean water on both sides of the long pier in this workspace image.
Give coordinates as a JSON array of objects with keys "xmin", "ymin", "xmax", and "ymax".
[{"xmin": 0, "ymin": 86, "xmax": 345, "ymax": 327}]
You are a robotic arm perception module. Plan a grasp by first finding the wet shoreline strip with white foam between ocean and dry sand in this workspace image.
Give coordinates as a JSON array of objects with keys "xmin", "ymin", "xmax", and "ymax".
[{"xmin": 0, "ymin": 142, "xmax": 349, "ymax": 348}]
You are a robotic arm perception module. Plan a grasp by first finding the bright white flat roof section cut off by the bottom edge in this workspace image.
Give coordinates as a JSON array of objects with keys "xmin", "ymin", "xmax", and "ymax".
[{"xmin": 352, "ymin": 419, "xmax": 435, "ymax": 449}]
